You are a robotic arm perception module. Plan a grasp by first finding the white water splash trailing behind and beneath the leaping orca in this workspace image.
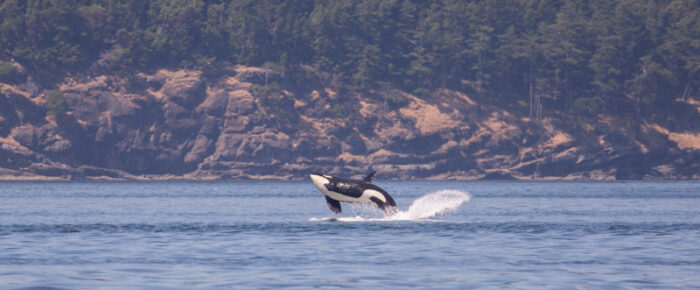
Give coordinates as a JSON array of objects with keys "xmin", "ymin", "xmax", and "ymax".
[{"xmin": 309, "ymin": 190, "xmax": 471, "ymax": 222}]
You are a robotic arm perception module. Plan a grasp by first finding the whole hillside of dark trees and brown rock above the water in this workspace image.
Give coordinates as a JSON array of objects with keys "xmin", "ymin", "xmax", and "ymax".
[{"xmin": 0, "ymin": 0, "xmax": 700, "ymax": 179}]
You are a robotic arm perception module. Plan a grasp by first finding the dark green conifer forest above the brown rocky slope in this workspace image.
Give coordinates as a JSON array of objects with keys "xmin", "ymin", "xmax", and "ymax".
[{"xmin": 0, "ymin": 0, "xmax": 700, "ymax": 121}]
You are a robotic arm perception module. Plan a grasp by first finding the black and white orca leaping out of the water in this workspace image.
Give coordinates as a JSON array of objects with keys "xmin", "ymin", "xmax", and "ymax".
[{"xmin": 309, "ymin": 171, "xmax": 397, "ymax": 216}]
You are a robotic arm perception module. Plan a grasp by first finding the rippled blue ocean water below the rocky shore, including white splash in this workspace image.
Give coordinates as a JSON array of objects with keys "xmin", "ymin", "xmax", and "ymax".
[{"xmin": 0, "ymin": 180, "xmax": 700, "ymax": 289}]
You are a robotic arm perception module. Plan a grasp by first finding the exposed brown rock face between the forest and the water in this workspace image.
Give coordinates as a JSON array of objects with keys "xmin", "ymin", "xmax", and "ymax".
[{"xmin": 0, "ymin": 66, "xmax": 700, "ymax": 179}]
